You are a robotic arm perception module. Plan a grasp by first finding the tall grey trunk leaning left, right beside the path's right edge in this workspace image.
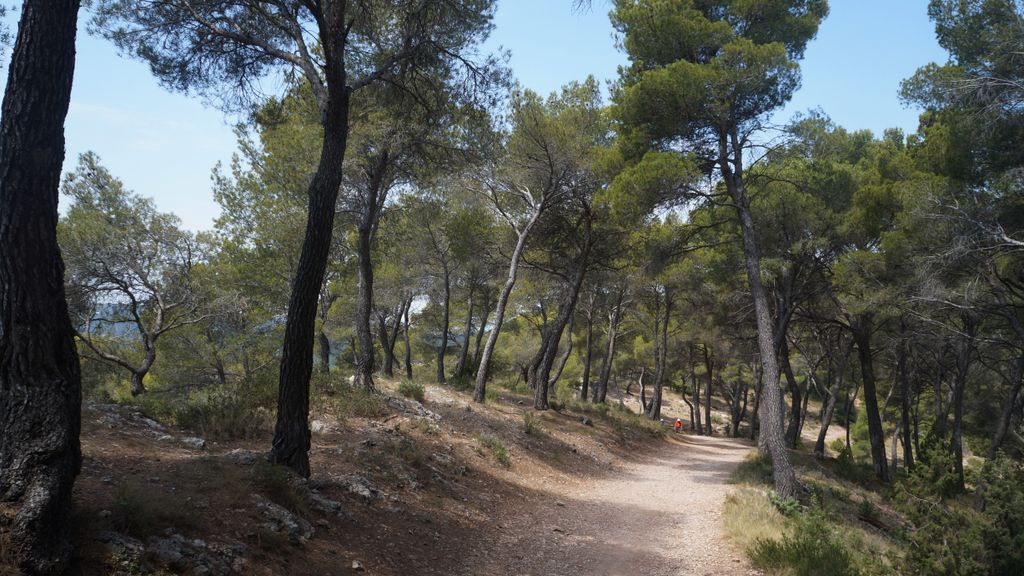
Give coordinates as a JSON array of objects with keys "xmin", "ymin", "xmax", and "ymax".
[{"xmin": 720, "ymin": 134, "xmax": 798, "ymax": 498}]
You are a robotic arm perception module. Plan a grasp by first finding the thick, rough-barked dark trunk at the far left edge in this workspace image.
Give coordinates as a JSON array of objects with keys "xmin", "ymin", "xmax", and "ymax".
[{"xmin": 0, "ymin": 0, "xmax": 82, "ymax": 574}]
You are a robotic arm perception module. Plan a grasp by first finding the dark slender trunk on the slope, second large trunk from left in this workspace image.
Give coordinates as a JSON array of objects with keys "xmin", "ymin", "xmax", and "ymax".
[{"xmin": 269, "ymin": 4, "xmax": 350, "ymax": 478}]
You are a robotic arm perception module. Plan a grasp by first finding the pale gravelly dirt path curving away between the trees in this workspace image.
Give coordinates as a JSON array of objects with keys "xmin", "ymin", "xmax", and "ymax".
[{"xmin": 462, "ymin": 436, "xmax": 757, "ymax": 576}]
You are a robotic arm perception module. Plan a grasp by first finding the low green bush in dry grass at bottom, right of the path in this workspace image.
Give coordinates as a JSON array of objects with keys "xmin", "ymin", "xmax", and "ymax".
[{"xmin": 748, "ymin": 512, "xmax": 859, "ymax": 576}]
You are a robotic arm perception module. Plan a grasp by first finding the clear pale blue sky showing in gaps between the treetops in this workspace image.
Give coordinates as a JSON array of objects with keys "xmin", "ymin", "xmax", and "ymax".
[{"xmin": 4, "ymin": 0, "xmax": 946, "ymax": 230}]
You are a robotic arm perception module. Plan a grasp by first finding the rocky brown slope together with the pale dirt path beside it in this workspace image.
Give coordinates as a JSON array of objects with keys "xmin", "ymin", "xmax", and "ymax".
[{"xmin": 12, "ymin": 379, "xmax": 750, "ymax": 576}]
